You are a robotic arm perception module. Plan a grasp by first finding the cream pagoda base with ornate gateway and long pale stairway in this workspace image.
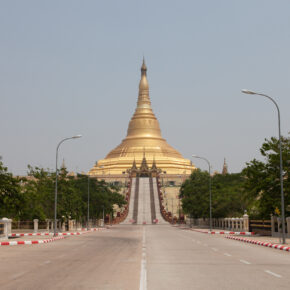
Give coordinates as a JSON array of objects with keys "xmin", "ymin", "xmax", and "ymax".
[{"xmin": 95, "ymin": 157, "xmax": 188, "ymax": 225}]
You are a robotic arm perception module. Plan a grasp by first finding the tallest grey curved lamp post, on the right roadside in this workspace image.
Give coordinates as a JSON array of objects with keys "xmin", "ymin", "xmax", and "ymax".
[{"xmin": 242, "ymin": 90, "xmax": 286, "ymax": 244}]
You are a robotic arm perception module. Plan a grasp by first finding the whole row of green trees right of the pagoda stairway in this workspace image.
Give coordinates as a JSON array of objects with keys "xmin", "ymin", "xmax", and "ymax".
[{"xmin": 180, "ymin": 137, "xmax": 290, "ymax": 219}]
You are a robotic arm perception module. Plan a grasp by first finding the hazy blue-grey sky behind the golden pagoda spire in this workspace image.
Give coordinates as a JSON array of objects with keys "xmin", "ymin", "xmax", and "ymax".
[{"xmin": 0, "ymin": 0, "xmax": 290, "ymax": 174}]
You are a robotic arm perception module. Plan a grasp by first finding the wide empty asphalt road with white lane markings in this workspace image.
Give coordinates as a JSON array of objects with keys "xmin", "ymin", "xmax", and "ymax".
[{"xmin": 0, "ymin": 225, "xmax": 290, "ymax": 290}]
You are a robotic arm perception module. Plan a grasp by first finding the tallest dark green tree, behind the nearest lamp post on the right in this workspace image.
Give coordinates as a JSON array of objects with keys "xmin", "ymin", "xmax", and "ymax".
[{"xmin": 242, "ymin": 137, "xmax": 290, "ymax": 219}]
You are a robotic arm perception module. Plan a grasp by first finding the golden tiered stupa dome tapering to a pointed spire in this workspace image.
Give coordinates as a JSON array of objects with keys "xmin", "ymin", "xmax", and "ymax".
[{"xmin": 89, "ymin": 59, "xmax": 195, "ymax": 176}]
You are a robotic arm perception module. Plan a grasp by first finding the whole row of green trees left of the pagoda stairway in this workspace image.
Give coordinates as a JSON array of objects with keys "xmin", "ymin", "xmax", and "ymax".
[{"xmin": 0, "ymin": 160, "xmax": 126, "ymax": 221}]
